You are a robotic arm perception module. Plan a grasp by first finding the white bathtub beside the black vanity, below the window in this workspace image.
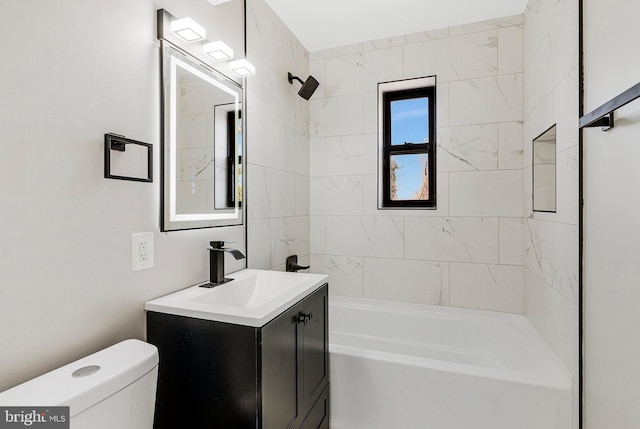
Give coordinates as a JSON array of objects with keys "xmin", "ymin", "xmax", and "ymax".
[{"xmin": 329, "ymin": 295, "xmax": 572, "ymax": 429}]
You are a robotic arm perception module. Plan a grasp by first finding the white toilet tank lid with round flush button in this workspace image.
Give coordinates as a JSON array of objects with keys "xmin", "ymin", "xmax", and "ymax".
[{"xmin": 0, "ymin": 340, "xmax": 158, "ymax": 416}]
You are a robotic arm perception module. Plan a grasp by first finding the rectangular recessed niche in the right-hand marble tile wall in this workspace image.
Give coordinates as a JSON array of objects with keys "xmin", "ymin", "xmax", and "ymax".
[{"xmin": 533, "ymin": 125, "xmax": 556, "ymax": 213}]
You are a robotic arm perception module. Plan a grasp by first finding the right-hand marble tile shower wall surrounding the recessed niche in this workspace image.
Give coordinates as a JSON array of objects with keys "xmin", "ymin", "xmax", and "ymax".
[{"xmin": 523, "ymin": 0, "xmax": 579, "ymax": 428}]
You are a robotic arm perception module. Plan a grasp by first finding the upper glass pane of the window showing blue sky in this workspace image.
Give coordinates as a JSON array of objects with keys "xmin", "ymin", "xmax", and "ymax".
[{"xmin": 390, "ymin": 97, "xmax": 429, "ymax": 145}]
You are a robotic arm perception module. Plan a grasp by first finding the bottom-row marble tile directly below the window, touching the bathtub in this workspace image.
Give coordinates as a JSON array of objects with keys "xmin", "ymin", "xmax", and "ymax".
[{"xmin": 364, "ymin": 258, "xmax": 449, "ymax": 305}]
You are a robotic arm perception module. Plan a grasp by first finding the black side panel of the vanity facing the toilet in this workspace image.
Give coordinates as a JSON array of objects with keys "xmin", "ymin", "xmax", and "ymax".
[{"xmin": 147, "ymin": 312, "xmax": 258, "ymax": 429}]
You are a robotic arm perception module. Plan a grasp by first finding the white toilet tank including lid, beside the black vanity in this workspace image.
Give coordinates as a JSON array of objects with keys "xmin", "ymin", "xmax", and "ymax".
[{"xmin": 0, "ymin": 340, "xmax": 158, "ymax": 429}]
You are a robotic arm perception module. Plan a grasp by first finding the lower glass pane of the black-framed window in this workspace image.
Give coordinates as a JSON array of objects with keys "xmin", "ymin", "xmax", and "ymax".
[{"xmin": 390, "ymin": 153, "xmax": 429, "ymax": 201}]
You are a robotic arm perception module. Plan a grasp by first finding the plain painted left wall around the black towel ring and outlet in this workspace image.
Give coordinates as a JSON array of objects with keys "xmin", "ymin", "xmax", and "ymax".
[{"xmin": 0, "ymin": 0, "xmax": 244, "ymax": 390}]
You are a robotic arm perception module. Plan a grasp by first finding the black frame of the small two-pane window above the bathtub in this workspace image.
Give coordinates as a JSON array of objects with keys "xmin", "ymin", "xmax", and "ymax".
[{"xmin": 379, "ymin": 85, "xmax": 437, "ymax": 209}]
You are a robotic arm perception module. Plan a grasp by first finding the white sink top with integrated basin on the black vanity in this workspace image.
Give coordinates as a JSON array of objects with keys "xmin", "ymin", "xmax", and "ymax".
[{"xmin": 144, "ymin": 269, "xmax": 327, "ymax": 327}]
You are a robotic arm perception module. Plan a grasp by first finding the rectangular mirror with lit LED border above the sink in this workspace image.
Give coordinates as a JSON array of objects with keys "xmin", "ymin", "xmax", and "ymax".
[{"xmin": 161, "ymin": 40, "xmax": 244, "ymax": 231}]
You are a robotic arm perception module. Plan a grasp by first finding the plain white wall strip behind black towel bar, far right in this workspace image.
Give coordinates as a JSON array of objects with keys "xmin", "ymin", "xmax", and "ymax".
[{"xmin": 583, "ymin": 0, "xmax": 640, "ymax": 429}]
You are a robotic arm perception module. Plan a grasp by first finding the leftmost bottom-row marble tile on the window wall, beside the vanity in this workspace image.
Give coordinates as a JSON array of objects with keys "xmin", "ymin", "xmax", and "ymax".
[{"xmin": 311, "ymin": 254, "xmax": 364, "ymax": 297}]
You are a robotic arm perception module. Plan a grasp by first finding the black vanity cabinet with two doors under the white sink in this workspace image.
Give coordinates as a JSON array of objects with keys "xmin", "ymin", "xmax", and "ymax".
[{"xmin": 147, "ymin": 283, "xmax": 329, "ymax": 429}]
